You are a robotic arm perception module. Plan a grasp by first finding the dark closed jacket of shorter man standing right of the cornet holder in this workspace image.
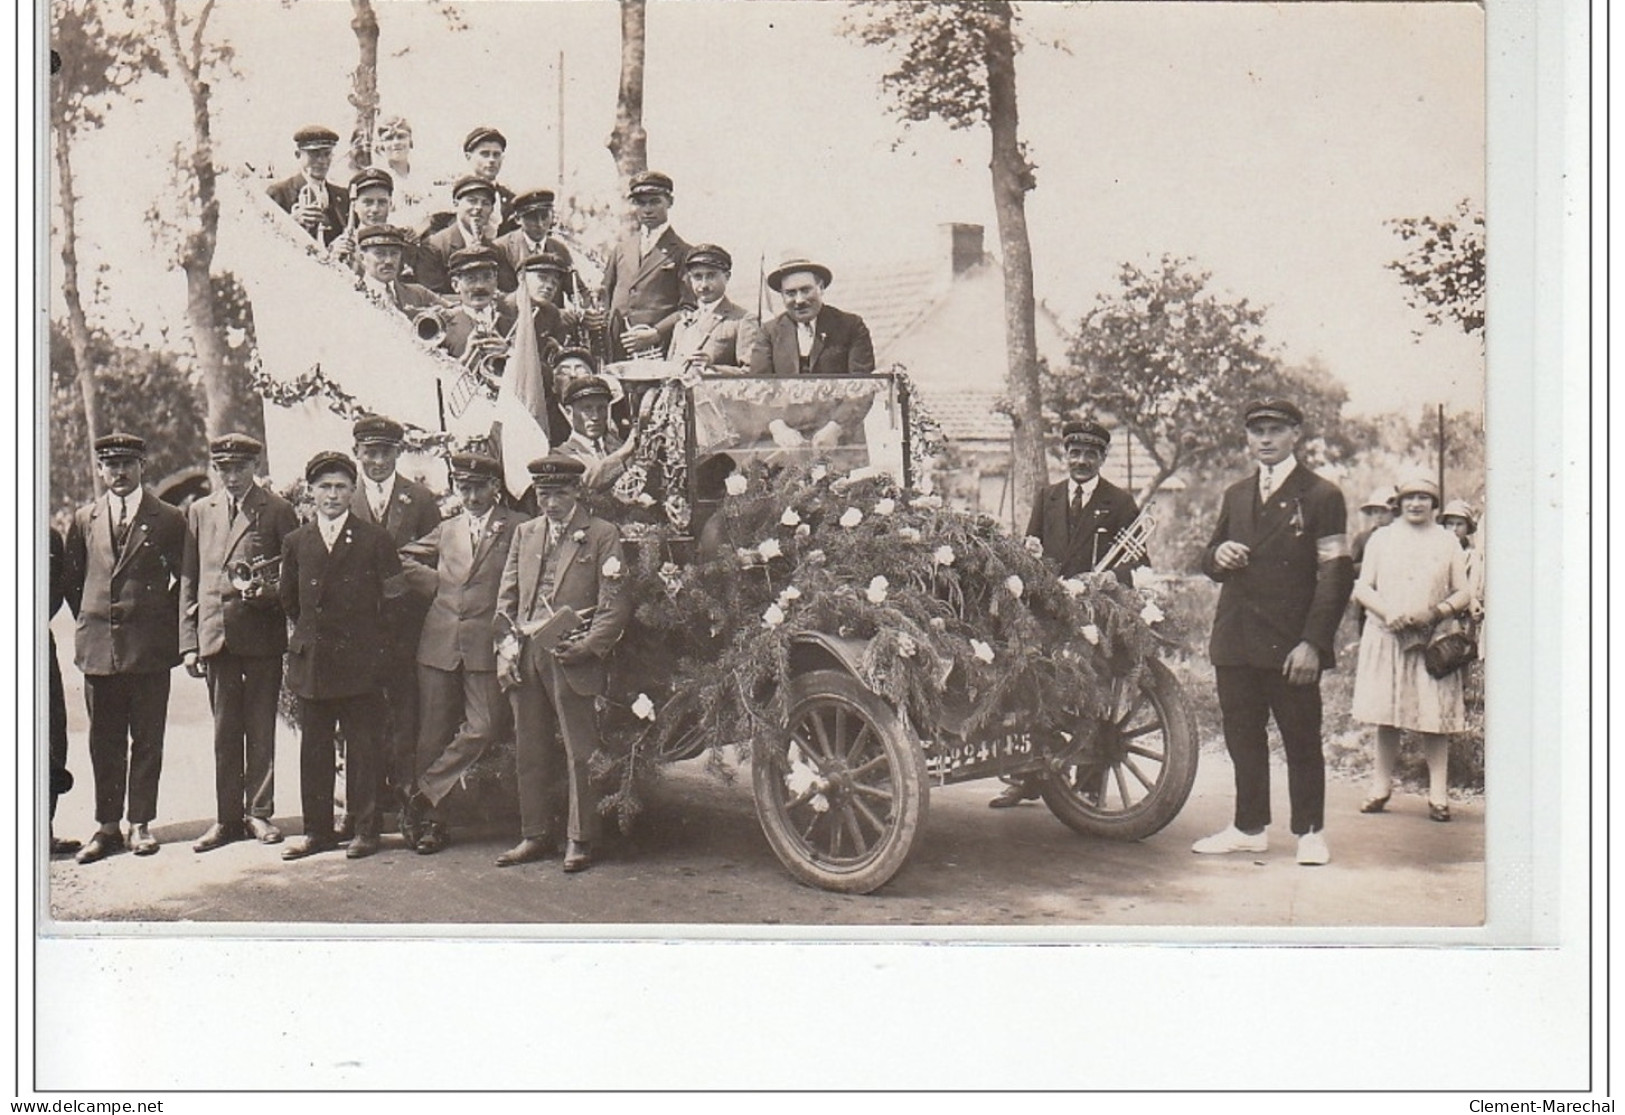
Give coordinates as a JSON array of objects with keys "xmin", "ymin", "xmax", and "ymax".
[{"xmin": 278, "ymin": 514, "xmax": 401, "ymax": 701}]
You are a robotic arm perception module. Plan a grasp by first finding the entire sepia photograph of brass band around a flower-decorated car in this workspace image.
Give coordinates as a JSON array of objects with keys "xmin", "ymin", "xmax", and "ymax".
[{"xmin": 37, "ymin": 0, "xmax": 1488, "ymax": 939}]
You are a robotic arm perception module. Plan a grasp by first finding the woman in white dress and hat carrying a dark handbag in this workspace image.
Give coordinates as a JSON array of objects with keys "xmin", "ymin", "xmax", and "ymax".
[{"xmin": 1352, "ymin": 479, "xmax": 1472, "ymax": 821}]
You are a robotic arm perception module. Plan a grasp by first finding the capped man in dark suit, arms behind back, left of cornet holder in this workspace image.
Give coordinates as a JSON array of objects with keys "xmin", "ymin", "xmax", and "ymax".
[{"xmin": 63, "ymin": 432, "xmax": 187, "ymax": 863}]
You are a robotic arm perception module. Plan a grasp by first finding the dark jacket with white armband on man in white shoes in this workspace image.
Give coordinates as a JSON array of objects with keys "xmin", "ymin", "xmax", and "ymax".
[{"xmin": 1203, "ymin": 463, "xmax": 1354, "ymax": 670}]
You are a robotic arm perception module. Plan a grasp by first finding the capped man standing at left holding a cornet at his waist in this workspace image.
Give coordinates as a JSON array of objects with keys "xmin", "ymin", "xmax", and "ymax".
[{"xmin": 180, "ymin": 434, "xmax": 299, "ymax": 852}]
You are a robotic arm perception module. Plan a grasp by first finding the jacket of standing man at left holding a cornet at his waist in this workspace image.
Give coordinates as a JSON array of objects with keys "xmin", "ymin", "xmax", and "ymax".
[{"xmin": 180, "ymin": 484, "xmax": 299, "ymax": 658}]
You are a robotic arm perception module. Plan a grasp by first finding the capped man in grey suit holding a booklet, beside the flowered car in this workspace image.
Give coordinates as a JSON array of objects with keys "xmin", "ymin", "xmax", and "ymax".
[{"xmin": 494, "ymin": 455, "xmax": 632, "ymax": 873}]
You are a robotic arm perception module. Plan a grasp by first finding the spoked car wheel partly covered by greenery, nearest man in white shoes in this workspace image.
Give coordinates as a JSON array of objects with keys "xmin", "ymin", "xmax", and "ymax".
[{"xmin": 1042, "ymin": 662, "xmax": 1198, "ymax": 840}]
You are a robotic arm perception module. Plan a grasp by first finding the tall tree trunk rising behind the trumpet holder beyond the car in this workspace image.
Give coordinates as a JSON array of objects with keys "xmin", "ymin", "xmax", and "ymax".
[{"xmin": 983, "ymin": 2, "xmax": 1050, "ymax": 520}]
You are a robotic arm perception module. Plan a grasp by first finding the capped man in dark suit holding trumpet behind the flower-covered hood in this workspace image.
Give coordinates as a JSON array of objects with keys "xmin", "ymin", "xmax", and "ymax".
[{"xmin": 988, "ymin": 421, "xmax": 1151, "ymax": 809}]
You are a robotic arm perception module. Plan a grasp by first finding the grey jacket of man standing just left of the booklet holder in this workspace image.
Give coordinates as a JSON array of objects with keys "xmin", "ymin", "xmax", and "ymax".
[{"xmin": 400, "ymin": 505, "xmax": 525, "ymax": 671}]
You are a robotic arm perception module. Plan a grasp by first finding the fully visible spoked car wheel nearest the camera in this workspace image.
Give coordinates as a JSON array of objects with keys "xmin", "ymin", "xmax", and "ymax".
[{"xmin": 751, "ymin": 670, "xmax": 928, "ymax": 894}]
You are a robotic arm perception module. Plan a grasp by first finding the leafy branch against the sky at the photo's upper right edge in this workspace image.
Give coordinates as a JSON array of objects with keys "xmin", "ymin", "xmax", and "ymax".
[{"xmin": 1386, "ymin": 198, "xmax": 1484, "ymax": 340}]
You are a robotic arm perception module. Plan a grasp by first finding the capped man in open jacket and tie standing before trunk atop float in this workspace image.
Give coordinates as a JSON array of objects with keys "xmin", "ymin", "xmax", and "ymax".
[{"xmin": 605, "ymin": 171, "xmax": 689, "ymax": 362}]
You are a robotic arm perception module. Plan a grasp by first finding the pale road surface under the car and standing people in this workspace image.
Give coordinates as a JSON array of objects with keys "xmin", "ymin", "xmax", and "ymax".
[{"xmin": 49, "ymin": 614, "xmax": 1484, "ymax": 931}]
